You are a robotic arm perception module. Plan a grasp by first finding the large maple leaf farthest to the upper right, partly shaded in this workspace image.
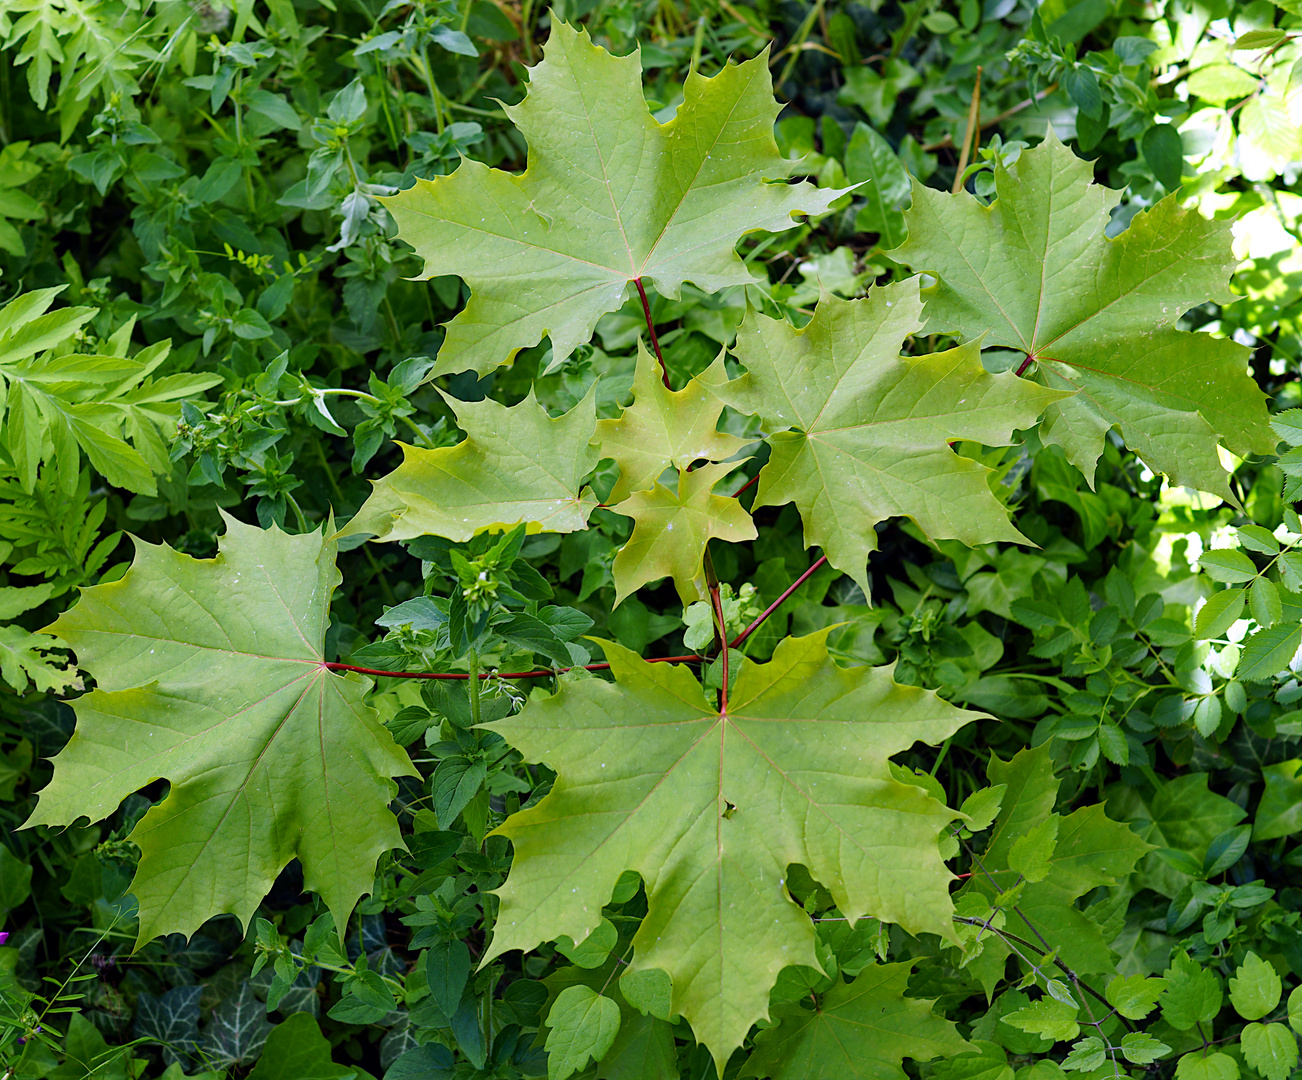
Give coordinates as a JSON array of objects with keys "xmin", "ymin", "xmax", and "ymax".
[{"xmin": 891, "ymin": 130, "xmax": 1275, "ymax": 499}]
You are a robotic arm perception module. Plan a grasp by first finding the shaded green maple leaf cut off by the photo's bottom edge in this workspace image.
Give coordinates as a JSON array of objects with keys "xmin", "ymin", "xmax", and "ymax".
[{"xmin": 741, "ymin": 963, "xmax": 971, "ymax": 1080}]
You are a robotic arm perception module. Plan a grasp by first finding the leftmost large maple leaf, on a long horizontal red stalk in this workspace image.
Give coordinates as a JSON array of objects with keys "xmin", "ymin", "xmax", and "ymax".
[{"xmin": 26, "ymin": 517, "xmax": 418, "ymax": 943}]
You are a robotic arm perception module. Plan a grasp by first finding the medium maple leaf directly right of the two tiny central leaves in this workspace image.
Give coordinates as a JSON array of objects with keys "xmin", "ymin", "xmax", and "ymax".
[{"xmin": 713, "ymin": 279, "xmax": 1062, "ymax": 591}]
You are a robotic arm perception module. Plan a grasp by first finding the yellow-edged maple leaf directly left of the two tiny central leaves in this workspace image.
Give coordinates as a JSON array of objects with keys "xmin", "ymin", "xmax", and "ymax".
[{"xmin": 340, "ymin": 384, "xmax": 598, "ymax": 543}]
